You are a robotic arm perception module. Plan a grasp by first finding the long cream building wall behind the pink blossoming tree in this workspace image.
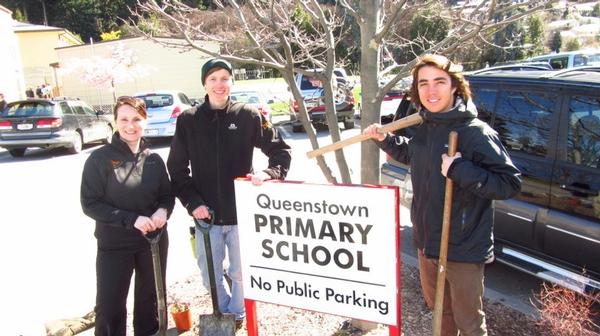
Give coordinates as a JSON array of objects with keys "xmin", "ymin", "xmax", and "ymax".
[{"xmin": 57, "ymin": 37, "xmax": 219, "ymax": 105}]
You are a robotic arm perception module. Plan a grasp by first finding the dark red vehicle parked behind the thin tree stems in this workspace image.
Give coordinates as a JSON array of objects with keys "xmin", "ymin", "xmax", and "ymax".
[{"xmin": 290, "ymin": 68, "xmax": 355, "ymax": 132}]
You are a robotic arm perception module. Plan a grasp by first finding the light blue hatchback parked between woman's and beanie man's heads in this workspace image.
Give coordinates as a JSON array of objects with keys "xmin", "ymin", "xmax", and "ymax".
[{"xmin": 135, "ymin": 90, "xmax": 195, "ymax": 138}]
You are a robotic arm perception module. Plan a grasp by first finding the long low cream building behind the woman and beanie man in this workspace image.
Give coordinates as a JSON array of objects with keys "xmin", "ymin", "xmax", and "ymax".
[{"xmin": 56, "ymin": 37, "xmax": 219, "ymax": 107}]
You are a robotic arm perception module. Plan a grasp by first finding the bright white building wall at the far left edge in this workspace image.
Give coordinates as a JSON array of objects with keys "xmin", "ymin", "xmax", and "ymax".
[{"xmin": 0, "ymin": 6, "xmax": 25, "ymax": 102}]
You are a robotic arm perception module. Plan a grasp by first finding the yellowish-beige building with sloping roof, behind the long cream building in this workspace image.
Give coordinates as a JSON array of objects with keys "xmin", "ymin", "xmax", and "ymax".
[{"xmin": 13, "ymin": 21, "xmax": 83, "ymax": 95}]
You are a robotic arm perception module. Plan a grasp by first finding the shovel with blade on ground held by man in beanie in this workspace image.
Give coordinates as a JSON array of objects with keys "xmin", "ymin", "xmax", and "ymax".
[{"xmin": 194, "ymin": 211, "xmax": 235, "ymax": 336}]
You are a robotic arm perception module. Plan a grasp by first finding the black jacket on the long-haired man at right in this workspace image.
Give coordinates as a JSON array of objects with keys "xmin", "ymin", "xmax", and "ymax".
[{"xmin": 376, "ymin": 98, "xmax": 521, "ymax": 263}]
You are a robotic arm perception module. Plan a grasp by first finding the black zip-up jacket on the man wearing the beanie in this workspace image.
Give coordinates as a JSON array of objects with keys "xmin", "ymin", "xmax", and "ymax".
[{"xmin": 167, "ymin": 95, "xmax": 291, "ymax": 225}]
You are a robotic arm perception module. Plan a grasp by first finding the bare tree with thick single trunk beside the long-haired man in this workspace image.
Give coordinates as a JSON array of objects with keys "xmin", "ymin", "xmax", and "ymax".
[{"xmin": 340, "ymin": 0, "xmax": 555, "ymax": 183}]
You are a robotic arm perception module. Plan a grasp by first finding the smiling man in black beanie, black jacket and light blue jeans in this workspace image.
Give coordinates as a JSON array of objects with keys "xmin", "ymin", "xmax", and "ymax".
[{"xmin": 167, "ymin": 58, "xmax": 291, "ymax": 327}]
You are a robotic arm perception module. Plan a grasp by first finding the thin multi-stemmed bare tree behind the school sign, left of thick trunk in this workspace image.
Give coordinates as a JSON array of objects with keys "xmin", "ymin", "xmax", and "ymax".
[{"xmin": 132, "ymin": 0, "xmax": 351, "ymax": 183}]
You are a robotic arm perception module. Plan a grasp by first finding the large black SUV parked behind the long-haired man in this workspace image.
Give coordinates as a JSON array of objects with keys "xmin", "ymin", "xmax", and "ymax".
[{"xmin": 381, "ymin": 69, "xmax": 600, "ymax": 293}]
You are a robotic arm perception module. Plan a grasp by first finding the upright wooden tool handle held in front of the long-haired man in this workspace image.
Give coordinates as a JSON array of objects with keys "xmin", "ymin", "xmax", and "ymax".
[{"xmin": 433, "ymin": 131, "xmax": 458, "ymax": 336}]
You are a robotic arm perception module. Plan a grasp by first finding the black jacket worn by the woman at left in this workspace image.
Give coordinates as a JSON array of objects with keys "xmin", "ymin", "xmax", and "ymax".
[{"xmin": 81, "ymin": 133, "xmax": 175, "ymax": 248}]
